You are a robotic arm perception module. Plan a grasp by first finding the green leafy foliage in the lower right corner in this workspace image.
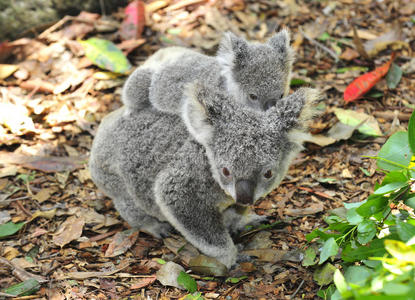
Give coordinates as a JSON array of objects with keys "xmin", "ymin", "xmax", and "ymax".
[{"xmin": 303, "ymin": 112, "xmax": 415, "ymax": 299}]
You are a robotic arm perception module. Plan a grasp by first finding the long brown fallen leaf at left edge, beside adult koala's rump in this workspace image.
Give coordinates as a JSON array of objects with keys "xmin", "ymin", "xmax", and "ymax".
[{"xmin": 0, "ymin": 151, "xmax": 87, "ymax": 173}]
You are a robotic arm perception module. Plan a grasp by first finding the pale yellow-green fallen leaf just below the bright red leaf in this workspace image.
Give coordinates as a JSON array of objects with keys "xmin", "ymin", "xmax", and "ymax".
[{"xmin": 334, "ymin": 108, "xmax": 382, "ymax": 136}]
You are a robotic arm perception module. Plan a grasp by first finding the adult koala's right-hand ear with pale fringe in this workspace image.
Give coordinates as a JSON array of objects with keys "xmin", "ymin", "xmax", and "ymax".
[{"xmin": 267, "ymin": 88, "xmax": 320, "ymax": 131}]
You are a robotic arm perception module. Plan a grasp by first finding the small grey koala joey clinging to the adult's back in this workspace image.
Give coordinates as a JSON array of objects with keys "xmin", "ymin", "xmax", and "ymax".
[{"xmin": 122, "ymin": 29, "xmax": 294, "ymax": 114}]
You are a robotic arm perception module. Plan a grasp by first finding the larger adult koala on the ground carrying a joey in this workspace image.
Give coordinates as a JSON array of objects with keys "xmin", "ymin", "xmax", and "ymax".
[{"xmin": 90, "ymin": 83, "xmax": 318, "ymax": 268}]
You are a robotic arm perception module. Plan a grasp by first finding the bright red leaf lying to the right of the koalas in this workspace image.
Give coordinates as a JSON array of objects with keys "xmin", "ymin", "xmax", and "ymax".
[{"xmin": 343, "ymin": 53, "xmax": 395, "ymax": 102}]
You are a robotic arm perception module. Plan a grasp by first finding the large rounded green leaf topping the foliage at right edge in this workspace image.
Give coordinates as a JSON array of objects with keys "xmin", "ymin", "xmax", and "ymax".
[{"xmin": 377, "ymin": 131, "xmax": 413, "ymax": 171}]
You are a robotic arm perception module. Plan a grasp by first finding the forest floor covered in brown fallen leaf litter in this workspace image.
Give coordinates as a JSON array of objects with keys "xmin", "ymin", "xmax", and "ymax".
[{"xmin": 0, "ymin": 0, "xmax": 415, "ymax": 299}]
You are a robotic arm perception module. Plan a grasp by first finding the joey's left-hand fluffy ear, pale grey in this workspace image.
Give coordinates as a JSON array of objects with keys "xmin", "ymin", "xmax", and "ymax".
[{"xmin": 216, "ymin": 32, "xmax": 248, "ymax": 67}]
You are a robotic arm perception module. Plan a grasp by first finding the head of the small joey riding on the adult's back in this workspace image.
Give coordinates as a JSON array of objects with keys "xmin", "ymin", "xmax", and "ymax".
[{"xmin": 216, "ymin": 29, "xmax": 294, "ymax": 110}]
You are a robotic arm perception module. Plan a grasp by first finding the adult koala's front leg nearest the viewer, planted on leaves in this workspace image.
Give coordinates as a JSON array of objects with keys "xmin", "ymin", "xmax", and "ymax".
[{"xmin": 154, "ymin": 174, "xmax": 237, "ymax": 268}]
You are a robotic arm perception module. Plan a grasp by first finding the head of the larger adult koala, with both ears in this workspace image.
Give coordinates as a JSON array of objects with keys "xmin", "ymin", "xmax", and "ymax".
[{"xmin": 182, "ymin": 84, "xmax": 318, "ymax": 205}]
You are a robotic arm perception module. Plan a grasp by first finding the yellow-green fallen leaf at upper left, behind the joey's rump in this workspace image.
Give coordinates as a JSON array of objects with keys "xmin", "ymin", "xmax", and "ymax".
[{"xmin": 79, "ymin": 38, "xmax": 131, "ymax": 74}]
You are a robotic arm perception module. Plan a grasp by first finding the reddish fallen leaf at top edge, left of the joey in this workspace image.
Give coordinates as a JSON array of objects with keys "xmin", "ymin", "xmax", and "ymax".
[{"xmin": 120, "ymin": 0, "xmax": 146, "ymax": 40}]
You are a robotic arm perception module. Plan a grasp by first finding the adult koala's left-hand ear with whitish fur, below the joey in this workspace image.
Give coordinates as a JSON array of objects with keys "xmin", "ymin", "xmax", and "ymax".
[{"xmin": 182, "ymin": 82, "xmax": 218, "ymax": 145}]
